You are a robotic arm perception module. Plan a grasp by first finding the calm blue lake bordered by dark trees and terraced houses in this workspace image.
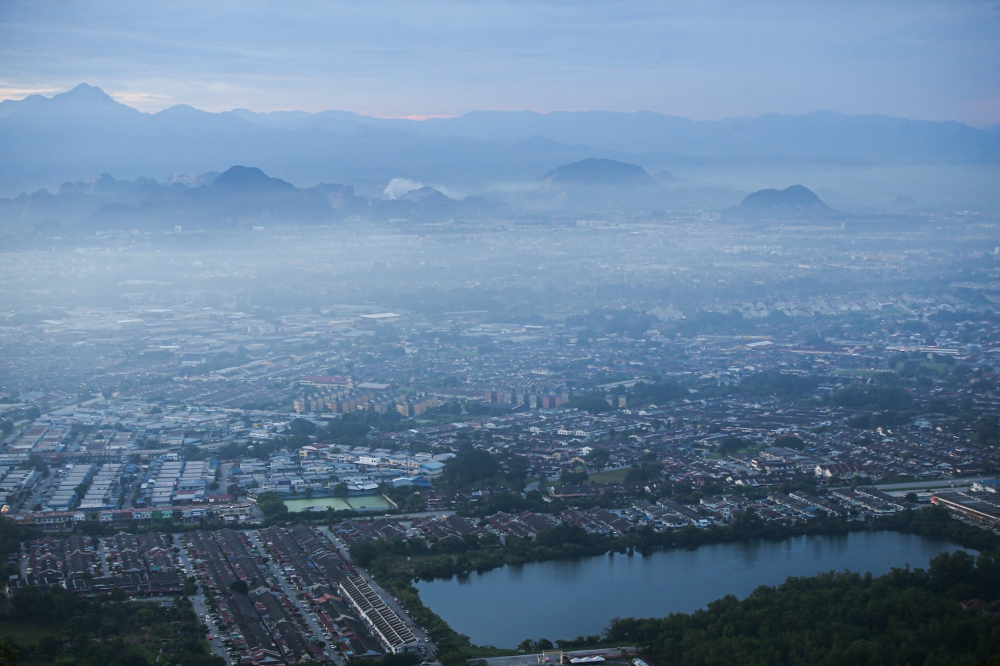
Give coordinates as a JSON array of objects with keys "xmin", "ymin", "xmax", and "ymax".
[{"xmin": 417, "ymin": 532, "xmax": 959, "ymax": 647}]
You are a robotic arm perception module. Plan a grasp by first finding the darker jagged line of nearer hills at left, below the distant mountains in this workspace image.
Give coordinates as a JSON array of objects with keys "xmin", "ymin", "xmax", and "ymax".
[{"xmin": 0, "ymin": 166, "xmax": 509, "ymax": 235}]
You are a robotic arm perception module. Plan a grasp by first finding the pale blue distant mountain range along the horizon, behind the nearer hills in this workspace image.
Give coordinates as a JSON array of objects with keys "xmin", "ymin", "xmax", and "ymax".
[{"xmin": 0, "ymin": 84, "xmax": 1000, "ymax": 201}]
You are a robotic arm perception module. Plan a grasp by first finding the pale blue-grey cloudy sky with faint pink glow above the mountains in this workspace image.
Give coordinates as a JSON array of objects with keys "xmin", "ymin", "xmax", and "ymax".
[{"xmin": 0, "ymin": 0, "xmax": 1000, "ymax": 126}]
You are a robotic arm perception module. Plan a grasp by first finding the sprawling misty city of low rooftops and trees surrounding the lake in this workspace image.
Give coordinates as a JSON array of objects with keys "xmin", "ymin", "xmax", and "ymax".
[{"xmin": 0, "ymin": 211, "xmax": 1000, "ymax": 666}]
